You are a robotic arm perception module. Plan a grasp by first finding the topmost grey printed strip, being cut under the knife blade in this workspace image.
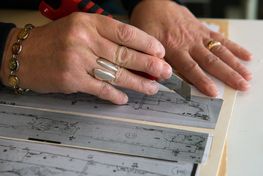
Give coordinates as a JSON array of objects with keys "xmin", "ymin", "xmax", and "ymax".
[{"xmin": 0, "ymin": 89, "xmax": 223, "ymax": 128}]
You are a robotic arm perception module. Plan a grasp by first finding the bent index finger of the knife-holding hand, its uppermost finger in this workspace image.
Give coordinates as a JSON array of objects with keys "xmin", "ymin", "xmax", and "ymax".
[{"xmin": 96, "ymin": 15, "xmax": 165, "ymax": 58}]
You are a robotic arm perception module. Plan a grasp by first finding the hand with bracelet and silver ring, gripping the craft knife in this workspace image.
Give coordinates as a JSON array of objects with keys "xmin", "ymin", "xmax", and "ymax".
[{"xmin": 1, "ymin": 13, "xmax": 172, "ymax": 104}]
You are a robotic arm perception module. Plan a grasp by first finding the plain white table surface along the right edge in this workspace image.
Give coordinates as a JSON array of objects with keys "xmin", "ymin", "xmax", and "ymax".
[{"xmin": 228, "ymin": 20, "xmax": 263, "ymax": 176}]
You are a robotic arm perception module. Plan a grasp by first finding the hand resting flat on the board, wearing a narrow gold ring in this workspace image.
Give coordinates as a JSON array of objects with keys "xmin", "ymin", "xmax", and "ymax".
[{"xmin": 131, "ymin": 0, "xmax": 252, "ymax": 96}]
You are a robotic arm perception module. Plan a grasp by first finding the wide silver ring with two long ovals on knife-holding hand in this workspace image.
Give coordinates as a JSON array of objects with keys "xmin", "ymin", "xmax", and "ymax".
[{"xmin": 93, "ymin": 58, "xmax": 119, "ymax": 82}]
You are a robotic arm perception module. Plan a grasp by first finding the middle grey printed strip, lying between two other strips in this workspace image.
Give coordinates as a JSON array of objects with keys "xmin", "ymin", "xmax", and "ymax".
[{"xmin": 0, "ymin": 105, "xmax": 211, "ymax": 163}]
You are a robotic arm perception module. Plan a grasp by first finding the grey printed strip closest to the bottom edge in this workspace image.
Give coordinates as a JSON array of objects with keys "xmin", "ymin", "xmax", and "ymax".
[{"xmin": 0, "ymin": 139, "xmax": 194, "ymax": 176}]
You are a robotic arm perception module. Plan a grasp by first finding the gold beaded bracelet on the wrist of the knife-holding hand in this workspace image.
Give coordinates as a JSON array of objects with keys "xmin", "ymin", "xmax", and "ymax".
[{"xmin": 8, "ymin": 24, "xmax": 34, "ymax": 94}]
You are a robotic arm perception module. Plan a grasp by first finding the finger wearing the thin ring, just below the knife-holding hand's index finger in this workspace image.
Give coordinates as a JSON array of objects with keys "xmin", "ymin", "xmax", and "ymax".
[{"xmin": 93, "ymin": 37, "xmax": 172, "ymax": 79}]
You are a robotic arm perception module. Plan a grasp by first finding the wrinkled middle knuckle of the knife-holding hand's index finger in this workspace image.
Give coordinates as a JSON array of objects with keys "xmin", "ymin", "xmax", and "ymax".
[{"xmin": 116, "ymin": 24, "xmax": 135, "ymax": 44}]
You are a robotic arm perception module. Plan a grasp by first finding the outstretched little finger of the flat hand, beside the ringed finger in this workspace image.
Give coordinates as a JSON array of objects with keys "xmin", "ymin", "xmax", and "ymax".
[{"xmin": 211, "ymin": 32, "xmax": 252, "ymax": 61}]
